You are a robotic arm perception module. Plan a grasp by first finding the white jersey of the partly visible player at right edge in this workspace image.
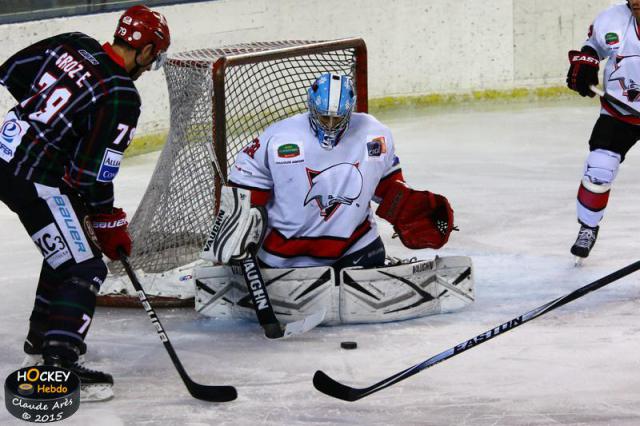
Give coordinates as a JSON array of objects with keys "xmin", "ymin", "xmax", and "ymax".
[{"xmin": 584, "ymin": 4, "xmax": 640, "ymax": 124}]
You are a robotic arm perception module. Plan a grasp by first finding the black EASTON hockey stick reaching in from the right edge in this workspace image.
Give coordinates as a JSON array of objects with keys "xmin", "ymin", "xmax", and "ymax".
[{"xmin": 313, "ymin": 261, "xmax": 640, "ymax": 401}]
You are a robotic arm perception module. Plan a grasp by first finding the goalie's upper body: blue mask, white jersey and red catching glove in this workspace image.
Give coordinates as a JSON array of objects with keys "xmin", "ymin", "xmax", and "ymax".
[{"xmin": 229, "ymin": 73, "xmax": 453, "ymax": 268}]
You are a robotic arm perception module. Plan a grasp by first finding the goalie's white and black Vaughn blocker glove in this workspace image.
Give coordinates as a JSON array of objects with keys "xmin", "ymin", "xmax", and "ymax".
[{"xmin": 200, "ymin": 186, "xmax": 267, "ymax": 264}]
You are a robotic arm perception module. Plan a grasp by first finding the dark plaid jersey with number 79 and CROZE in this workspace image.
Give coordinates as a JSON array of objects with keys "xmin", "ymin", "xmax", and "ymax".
[{"xmin": 0, "ymin": 33, "xmax": 140, "ymax": 212}]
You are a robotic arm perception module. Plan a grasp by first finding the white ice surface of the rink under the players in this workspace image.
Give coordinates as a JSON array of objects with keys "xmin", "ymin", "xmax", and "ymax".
[{"xmin": 0, "ymin": 100, "xmax": 640, "ymax": 426}]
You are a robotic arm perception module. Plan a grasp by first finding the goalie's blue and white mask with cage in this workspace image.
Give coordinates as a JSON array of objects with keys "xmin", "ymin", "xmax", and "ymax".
[{"xmin": 308, "ymin": 73, "xmax": 356, "ymax": 149}]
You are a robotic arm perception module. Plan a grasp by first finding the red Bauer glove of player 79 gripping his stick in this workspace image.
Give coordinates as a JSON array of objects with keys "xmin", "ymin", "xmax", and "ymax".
[{"xmin": 91, "ymin": 208, "xmax": 131, "ymax": 260}]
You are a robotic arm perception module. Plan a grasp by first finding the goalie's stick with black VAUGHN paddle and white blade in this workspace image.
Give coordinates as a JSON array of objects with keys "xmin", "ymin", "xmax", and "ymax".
[{"xmin": 240, "ymin": 246, "xmax": 327, "ymax": 339}]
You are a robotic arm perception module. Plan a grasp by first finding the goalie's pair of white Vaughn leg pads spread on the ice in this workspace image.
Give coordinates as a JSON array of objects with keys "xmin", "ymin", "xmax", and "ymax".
[{"xmin": 193, "ymin": 256, "xmax": 475, "ymax": 325}]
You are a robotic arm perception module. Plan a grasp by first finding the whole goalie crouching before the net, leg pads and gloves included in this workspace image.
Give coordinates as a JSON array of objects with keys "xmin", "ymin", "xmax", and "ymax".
[{"xmin": 193, "ymin": 74, "xmax": 474, "ymax": 326}]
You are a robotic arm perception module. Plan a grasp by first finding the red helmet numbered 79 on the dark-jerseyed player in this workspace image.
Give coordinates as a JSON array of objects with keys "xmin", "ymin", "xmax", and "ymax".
[{"xmin": 113, "ymin": 5, "xmax": 171, "ymax": 55}]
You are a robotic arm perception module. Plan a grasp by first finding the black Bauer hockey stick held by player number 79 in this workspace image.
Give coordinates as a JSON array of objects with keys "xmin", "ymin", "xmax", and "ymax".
[{"xmin": 118, "ymin": 248, "xmax": 238, "ymax": 402}]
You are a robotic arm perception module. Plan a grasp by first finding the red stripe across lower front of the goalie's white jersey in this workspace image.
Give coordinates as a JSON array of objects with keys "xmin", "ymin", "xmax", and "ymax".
[{"xmin": 262, "ymin": 219, "xmax": 371, "ymax": 259}]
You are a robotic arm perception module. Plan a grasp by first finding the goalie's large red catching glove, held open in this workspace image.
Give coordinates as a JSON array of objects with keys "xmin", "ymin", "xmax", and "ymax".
[{"xmin": 376, "ymin": 181, "xmax": 453, "ymax": 249}]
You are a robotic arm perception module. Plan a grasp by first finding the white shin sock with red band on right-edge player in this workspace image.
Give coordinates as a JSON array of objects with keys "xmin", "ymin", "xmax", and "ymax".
[{"xmin": 577, "ymin": 149, "xmax": 621, "ymax": 228}]
